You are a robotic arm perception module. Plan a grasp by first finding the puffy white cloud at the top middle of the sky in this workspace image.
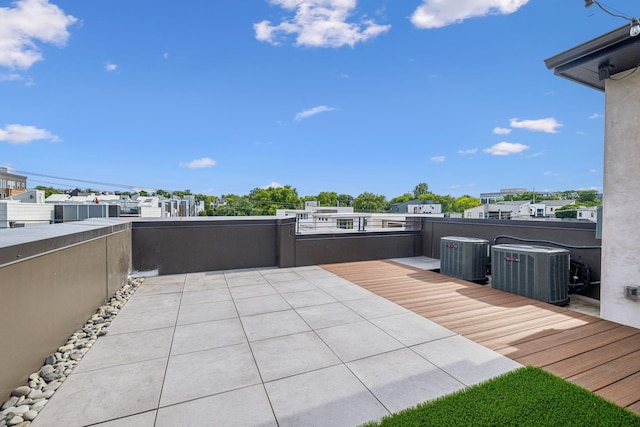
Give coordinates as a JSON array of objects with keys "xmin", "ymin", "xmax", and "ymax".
[{"xmin": 253, "ymin": 0, "xmax": 391, "ymax": 47}]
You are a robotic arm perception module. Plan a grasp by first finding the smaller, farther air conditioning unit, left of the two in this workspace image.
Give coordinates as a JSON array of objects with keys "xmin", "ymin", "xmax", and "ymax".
[{"xmin": 440, "ymin": 236, "xmax": 489, "ymax": 283}]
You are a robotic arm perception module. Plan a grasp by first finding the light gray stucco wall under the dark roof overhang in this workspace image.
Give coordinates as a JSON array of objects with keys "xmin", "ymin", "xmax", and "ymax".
[{"xmin": 600, "ymin": 71, "xmax": 640, "ymax": 328}]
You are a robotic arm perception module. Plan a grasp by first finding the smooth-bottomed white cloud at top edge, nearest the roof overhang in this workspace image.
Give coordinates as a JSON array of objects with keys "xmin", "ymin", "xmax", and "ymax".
[{"xmin": 411, "ymin": 0, "xmax": 529, "ymax": 28}]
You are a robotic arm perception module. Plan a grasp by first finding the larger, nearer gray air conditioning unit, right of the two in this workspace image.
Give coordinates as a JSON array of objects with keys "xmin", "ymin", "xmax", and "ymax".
[{"xmin": 491, "ymin": 244, "xmax": 569, "ymax": 306}]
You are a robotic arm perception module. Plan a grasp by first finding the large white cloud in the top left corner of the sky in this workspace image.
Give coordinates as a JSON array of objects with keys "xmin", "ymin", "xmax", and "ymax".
[{"xmin": 0, "ymin": 0, "xmax": 77, "ymax": 69}]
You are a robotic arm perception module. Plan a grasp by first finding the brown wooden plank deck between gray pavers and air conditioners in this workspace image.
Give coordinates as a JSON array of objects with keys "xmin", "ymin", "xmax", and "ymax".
[{"xmin": 322, "ymin": 261, "xmax": 640, "ymax": 413}]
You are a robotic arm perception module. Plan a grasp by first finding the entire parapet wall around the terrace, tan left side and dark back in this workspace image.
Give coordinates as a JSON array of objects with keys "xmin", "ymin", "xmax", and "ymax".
[{"xmin": 0, "ymin": 217, "xmax": 600, "ymax": 401}]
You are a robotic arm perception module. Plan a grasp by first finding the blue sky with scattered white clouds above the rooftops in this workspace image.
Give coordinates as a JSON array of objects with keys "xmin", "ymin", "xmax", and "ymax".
[{"xmin": 0, "ymin": 0, "xmax": 640, "ymax": 199}]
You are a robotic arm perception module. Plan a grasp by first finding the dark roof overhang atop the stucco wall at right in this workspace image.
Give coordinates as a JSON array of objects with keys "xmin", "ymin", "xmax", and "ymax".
[{"xmin": 544, "ymin": 24, "xmax": 640, "ymax": 91}]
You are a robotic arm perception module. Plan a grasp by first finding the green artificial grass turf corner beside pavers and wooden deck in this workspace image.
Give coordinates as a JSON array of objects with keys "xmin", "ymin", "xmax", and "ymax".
[{"xmin": 365, "ymin": 366, "xmax": 640, "ymax": 427}]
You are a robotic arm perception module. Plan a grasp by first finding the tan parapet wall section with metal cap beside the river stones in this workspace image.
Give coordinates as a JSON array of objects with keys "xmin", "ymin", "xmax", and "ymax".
[{"xmin": 0, "ymin": 220, "xmax": 131, "ymax": 401}]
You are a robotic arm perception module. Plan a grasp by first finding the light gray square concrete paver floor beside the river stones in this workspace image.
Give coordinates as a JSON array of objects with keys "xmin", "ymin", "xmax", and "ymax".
[{"xmin": 32, "ymin": 260, "xmax": 520, "ymax": 427}]
